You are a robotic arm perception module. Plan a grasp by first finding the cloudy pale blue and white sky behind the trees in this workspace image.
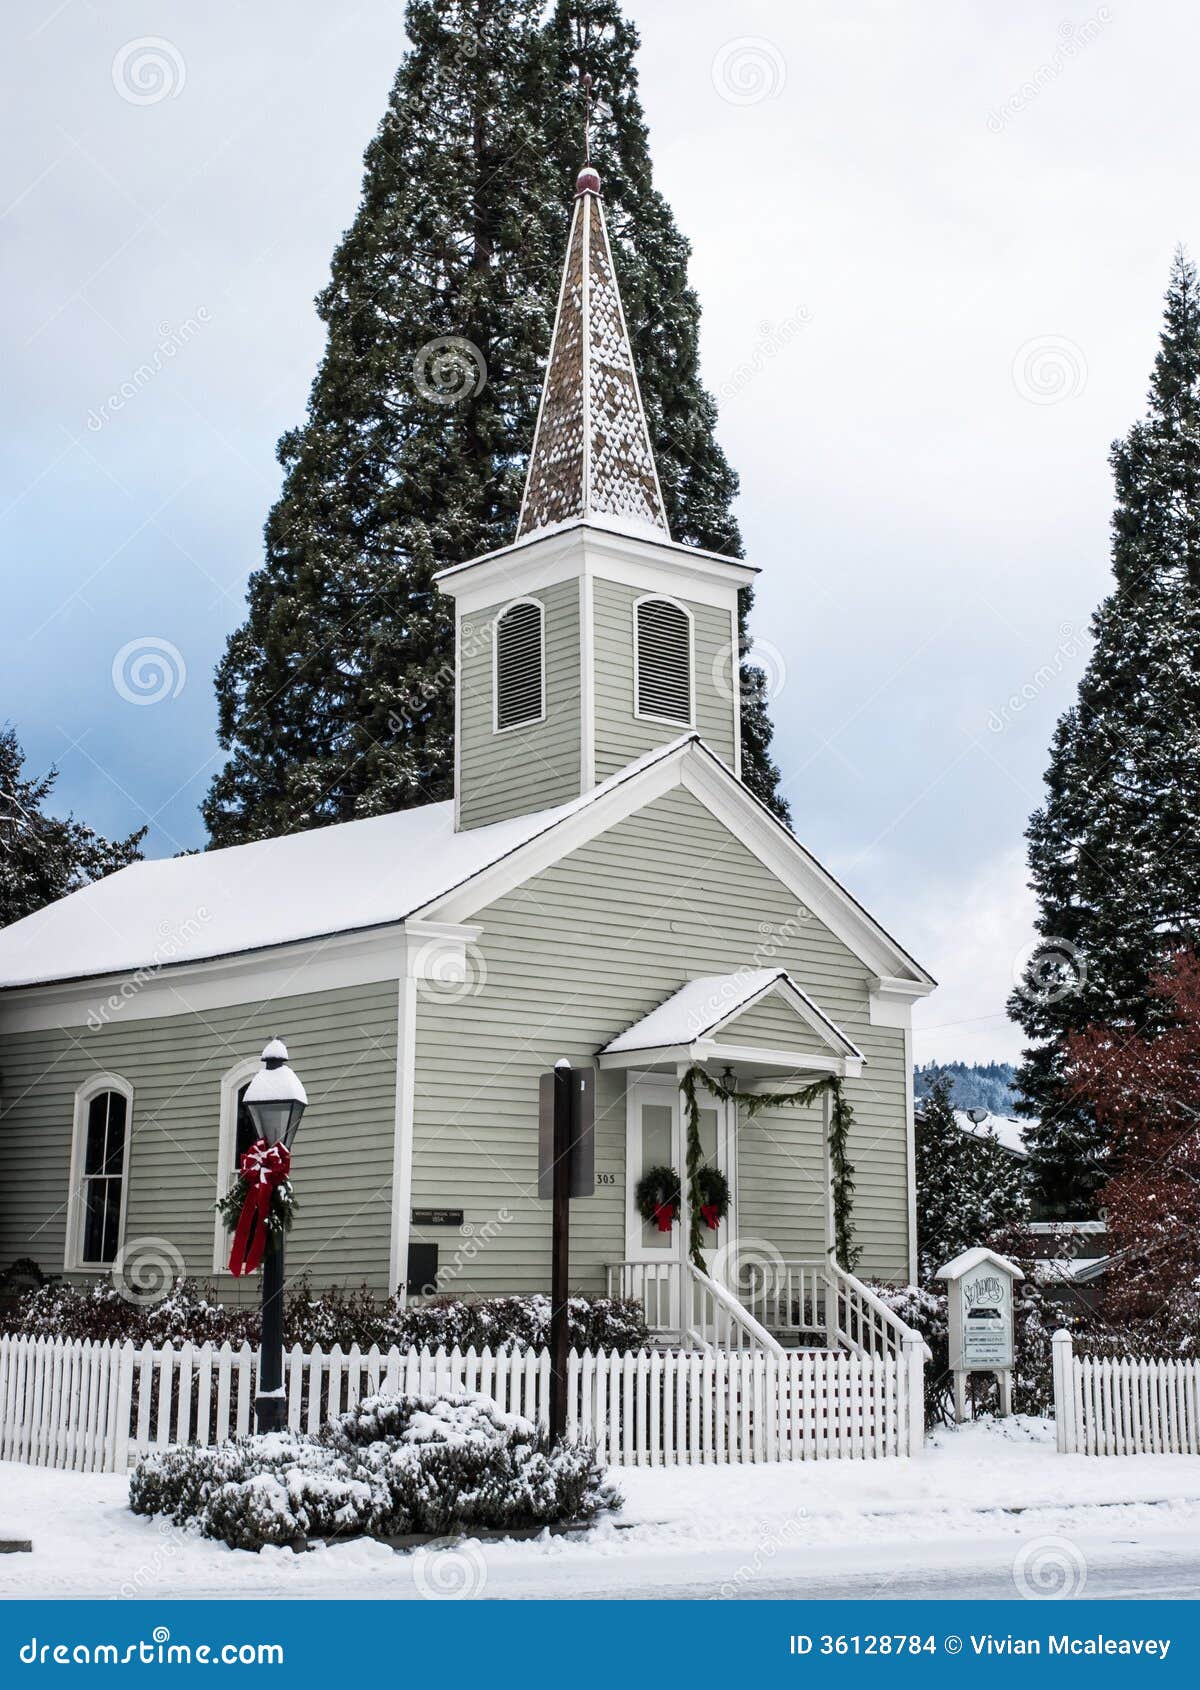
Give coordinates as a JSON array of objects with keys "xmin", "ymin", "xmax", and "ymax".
[{"xmin": 0, "ymin": 0, "xmax": 1200, "ymax": 1060}]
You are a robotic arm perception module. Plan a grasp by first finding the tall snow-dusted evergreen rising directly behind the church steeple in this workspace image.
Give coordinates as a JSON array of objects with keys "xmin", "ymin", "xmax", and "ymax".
[{"xmin": 203, "ymin": 0, "xmax": 781, "ymax": 845}]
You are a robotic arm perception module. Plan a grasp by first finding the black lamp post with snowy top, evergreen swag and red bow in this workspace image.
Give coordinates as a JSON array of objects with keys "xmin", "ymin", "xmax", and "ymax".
[{"xmin": 218, "ymin": 1039, "xmax": 308, "ymax": 1431}]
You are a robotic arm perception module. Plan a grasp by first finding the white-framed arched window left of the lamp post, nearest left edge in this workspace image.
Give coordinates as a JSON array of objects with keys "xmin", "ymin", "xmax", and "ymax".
[{"xmin": 64, "ymin": 1073, "xmax": 134, "ymax": 1269}]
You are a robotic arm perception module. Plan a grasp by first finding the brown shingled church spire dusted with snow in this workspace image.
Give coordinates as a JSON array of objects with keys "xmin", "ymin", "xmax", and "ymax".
[{"xmin": 517, "ymin": 164, "xmax": 669, "ymax": 539}]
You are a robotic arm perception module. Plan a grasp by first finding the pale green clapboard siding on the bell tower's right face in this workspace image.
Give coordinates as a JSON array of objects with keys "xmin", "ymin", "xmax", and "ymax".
[{"xmin": 593, "ymin": 580, "xmax": 735, "ymax": 781}]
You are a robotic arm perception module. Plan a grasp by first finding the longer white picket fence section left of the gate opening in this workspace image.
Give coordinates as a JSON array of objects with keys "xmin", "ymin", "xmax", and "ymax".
[{"xmin": 0, "ymin": 1337, "xmax": 925, "ymax": 1472}]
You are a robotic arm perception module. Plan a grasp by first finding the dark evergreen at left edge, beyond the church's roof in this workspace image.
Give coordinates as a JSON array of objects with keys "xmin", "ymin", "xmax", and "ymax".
[{"xmin": 0, "ymin": 728, "xmax": 145, "ymax": 928}]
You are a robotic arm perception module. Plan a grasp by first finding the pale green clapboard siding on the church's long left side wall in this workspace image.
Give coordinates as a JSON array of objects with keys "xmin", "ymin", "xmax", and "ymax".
[{"xmin": 0, "ymin": 982, "xmax": 397, "ymax": 1301}]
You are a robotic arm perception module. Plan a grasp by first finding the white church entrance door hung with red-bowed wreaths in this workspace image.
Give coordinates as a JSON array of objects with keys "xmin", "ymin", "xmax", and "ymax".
[{"xmin": 625, "ymin": 1075, "xmax": 737, "ymax": 1327}]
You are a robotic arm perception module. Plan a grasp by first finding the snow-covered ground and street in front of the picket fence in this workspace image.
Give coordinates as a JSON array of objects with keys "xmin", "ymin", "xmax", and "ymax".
[{"xmin": 0, "ymin": 1418, "xmax": 1200, "ymax": 1599}]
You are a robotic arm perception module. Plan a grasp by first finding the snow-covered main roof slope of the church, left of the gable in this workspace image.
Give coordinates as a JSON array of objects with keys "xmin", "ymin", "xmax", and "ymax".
[{"xmin": 0, "ymin": 735, "xmax": 695, "ymax": 990}]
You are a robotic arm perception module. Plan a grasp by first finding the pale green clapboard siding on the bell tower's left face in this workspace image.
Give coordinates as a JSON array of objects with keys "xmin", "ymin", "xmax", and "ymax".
[{"xmin": 458, "ymin": 581, "xmax": 581, "ymax": 828}]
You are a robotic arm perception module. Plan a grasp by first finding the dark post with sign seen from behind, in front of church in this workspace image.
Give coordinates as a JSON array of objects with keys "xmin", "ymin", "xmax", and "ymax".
[{"xmin": 537, "ymin": 1058, "xmax": 595, "ymax": 1443}]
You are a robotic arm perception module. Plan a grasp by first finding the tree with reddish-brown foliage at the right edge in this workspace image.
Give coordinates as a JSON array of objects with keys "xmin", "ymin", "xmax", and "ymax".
[{"xmin": 1066, "ymin": 950, "xmax": 1200, "ymax": 1320}]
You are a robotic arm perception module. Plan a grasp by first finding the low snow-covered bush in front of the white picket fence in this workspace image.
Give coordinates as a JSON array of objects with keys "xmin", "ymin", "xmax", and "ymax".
[{"xmin": 130, "ymin": 1396, "xmax": 620, "ymax": 1550}]
